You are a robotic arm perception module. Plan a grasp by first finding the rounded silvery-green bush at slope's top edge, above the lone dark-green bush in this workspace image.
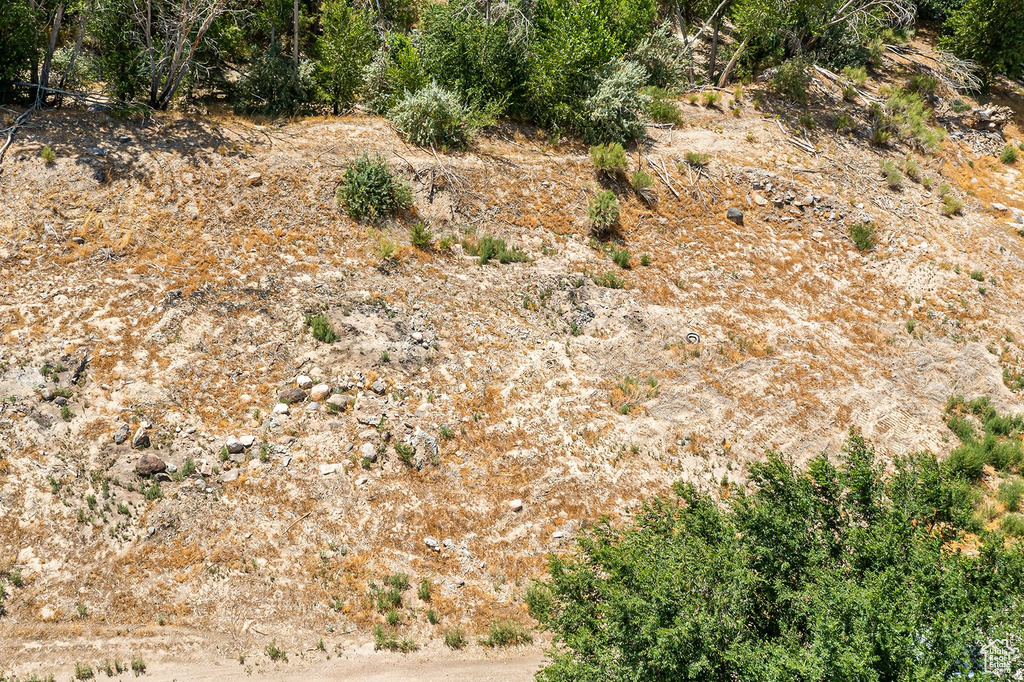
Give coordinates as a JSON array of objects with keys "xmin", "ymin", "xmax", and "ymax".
[{"xmin": 388, "ymin": 82, "xmax": 470, "ymax": 148}]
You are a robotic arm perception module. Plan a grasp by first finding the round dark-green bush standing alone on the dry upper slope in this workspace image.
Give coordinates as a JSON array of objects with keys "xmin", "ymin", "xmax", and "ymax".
[{"xmin": 337, "ymin": 154, "xmax": 413, "ymax": 220}]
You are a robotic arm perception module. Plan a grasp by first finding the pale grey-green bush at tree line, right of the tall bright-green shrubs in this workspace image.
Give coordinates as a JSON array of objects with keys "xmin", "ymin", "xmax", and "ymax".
[{"xmin": 583, "ymin": 61, "xmax": 650, "ymax": 142}]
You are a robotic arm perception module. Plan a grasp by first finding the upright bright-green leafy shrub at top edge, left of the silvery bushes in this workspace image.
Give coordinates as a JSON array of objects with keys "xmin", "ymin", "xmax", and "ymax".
[{"xmin": 314, "ymin": 0, "xmax": 378, "ymax": 114}]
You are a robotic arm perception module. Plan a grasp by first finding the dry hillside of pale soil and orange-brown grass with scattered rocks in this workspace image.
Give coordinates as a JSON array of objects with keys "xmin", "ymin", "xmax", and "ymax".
[{"xmin": 0, "ymin": 38, "xmax": 1024, "ymax": 679}]
